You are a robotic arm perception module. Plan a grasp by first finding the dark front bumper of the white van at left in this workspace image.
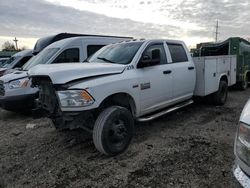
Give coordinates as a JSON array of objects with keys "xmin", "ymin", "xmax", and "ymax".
[{"xmin": 0, "ymin": 93, "xmax": 38, "ymax": 111}]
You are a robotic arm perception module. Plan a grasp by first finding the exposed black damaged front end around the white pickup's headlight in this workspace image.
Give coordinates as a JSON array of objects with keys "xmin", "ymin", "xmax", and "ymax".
[{"xmin": 32, "ymin": 76, "xmax": 95, "ymax": 132}]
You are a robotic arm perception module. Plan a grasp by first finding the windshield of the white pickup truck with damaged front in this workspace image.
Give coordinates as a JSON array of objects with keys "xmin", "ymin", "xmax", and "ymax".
[{"xmin": 87, "ymin": 42, "xmax": 143, "ymax": 64}]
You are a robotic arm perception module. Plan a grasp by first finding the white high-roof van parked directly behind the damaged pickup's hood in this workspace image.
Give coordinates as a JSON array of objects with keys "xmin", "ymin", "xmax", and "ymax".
[{"xmin": 0, "ymin": 36, "xmax": 132, "ymax": 112}]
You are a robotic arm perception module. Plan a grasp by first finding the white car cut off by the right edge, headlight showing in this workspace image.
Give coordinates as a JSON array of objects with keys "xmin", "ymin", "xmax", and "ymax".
[{"xmin": 234, "ymin": 100, "xmax": 250, "ymax": 188}]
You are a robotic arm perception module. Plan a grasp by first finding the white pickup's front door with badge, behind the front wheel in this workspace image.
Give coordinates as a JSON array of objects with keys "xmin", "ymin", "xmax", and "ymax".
[{"xmin": 137, "ymin": 43, "xmax": 173, "ymax": 114}]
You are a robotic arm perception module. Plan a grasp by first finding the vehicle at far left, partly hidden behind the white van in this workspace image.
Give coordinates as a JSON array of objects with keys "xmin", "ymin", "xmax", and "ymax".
[{"xmin": 0, "ymin": 50, "xmax": 33, "ymax": 76}]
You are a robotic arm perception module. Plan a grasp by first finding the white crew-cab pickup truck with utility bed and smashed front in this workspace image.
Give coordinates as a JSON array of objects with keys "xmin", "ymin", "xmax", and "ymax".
[{"xmin": 28, "ymin": 40, "xmax": 236, "ymax": 156}]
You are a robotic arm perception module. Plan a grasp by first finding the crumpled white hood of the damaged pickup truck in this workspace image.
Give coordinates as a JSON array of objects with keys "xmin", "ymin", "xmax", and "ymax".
[{"xmin": 28, "ymin": 63, "xmax": 125, "ymax": 84}]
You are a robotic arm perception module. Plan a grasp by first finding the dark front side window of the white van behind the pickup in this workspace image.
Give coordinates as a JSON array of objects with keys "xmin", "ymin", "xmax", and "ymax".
[{"xmin": 53, "ymin": 48, "xmax": 80, "ymax": 63}]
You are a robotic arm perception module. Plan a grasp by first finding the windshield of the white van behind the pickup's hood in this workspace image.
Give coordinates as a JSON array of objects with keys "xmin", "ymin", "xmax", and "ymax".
[{"xmin": 23, "ymin": 48, "xmax": 59, "ymax": 70}]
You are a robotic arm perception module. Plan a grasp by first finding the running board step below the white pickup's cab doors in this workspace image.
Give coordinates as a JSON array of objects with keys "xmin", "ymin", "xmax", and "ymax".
[{"xmin": 137, "ymin": 100, "xmax": 194, "ymax": 122}]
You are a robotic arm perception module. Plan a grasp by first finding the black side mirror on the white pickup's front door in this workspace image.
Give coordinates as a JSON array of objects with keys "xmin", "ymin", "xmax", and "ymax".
[{"xmin": 137, "ymin": 49, "xmax": 161, "ymax": 68}]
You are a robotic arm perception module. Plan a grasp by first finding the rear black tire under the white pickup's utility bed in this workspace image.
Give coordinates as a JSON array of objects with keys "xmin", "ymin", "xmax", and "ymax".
[{"xmin": 212, "ymin": 80, "xmax": 228, "ymax": 105}]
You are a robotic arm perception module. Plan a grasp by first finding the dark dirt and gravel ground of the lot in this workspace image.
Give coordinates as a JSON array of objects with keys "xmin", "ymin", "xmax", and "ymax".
[{"xmin": 0, "ymin": 89, "xmax": 250, "ymax": 188}]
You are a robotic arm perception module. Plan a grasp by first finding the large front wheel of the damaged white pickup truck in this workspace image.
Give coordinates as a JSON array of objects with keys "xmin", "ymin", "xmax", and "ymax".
[{"xmin": 93, "ymin": 106, "xmax": 134, "ymax": 156}]
